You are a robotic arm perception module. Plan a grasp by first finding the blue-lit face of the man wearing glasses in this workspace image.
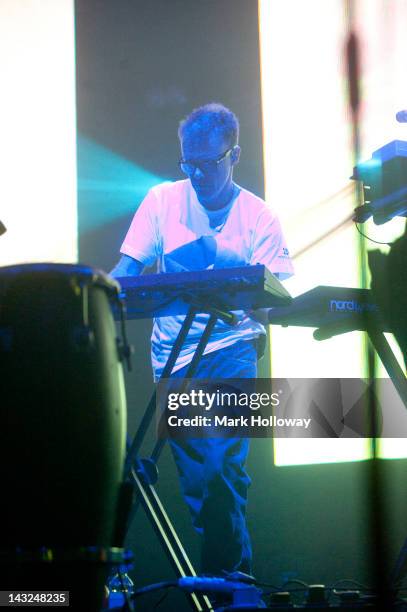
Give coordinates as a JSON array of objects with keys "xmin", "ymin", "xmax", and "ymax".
[{"xmin": 181, "ymin": 132, "xmax": 240, "ymax": 209}]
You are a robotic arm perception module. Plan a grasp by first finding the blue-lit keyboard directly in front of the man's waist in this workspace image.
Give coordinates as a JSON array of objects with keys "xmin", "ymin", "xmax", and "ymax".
[{"xmin": 114, "ymin": 264, "xmax": 292, "ymax": 319}]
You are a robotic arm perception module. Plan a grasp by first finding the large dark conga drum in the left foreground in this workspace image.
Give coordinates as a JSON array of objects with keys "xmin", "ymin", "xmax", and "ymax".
[{"xmin": 0, "ymin": 264, "xmax": 126, "ymax": 610}]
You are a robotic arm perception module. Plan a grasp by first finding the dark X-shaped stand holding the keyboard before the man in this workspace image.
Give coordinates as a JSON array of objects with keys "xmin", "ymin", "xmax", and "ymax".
[{"xmin": 125, "ymin": 299, "xmax": 235, "ymax": 612}]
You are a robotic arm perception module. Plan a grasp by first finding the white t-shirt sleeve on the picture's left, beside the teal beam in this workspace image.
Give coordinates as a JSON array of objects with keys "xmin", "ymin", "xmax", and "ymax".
[{"xmin": 120, "ymin": 189, "xmax": 160, "ymax": 266}]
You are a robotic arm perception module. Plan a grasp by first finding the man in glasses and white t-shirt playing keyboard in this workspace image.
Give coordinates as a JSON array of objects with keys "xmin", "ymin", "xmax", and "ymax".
[{"xmin": 112, "ymin": 103, "xmax": 292, "ymax": 574}]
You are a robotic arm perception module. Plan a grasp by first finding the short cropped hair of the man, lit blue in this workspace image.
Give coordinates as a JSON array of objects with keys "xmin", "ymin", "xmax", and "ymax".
[{"xmin": 178, "ymin": 102, "xmax": 239, "ymax": 146}]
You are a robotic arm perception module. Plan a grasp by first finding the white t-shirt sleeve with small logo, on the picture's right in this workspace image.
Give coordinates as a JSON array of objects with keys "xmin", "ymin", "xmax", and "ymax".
[{"xmin": 250, "ymin": 208, "xmax": 294, "ymax": 280}]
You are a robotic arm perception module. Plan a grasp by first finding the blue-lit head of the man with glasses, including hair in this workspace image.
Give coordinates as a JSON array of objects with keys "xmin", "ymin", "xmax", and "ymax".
[{"xmin": 178, "ymin": 103, "xmax": 240, "ymax": 209}]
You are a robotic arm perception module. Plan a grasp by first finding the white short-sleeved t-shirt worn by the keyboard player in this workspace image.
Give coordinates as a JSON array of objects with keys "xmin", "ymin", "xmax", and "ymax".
[{"xmin": 120, "ymin": 179, "xmax": 293, "ymax": 379}]
